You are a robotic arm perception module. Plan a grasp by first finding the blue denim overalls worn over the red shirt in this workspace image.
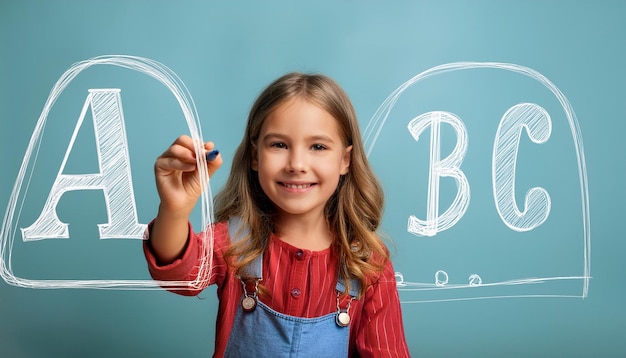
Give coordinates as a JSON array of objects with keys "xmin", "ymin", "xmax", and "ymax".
[{"xmin": 224, "ymin": 218, "xmax": 359, "ymax": 358}]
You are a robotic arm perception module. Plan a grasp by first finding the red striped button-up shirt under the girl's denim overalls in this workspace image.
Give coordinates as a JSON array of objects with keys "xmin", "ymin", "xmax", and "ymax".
[{"xmin": 144, "ymin": 222, "xmax": 409, "ymax": 357}]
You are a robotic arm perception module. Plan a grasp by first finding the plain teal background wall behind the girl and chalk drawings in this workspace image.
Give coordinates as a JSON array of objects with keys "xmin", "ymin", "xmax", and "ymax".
[{"xmin": 0, "ymin": 1, "xmax": 626, "ymax": 357}]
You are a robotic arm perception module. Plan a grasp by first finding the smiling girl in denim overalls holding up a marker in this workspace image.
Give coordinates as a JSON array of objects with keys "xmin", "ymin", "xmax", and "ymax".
[{"xmin": 144, "ymin": 73, "xmax": 409, "ymax": 357}]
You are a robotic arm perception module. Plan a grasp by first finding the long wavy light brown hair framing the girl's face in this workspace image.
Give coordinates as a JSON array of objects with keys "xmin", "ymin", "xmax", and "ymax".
[{"xmin": 215, "ymin": 73, "xmax": 388, "ymax": 296}]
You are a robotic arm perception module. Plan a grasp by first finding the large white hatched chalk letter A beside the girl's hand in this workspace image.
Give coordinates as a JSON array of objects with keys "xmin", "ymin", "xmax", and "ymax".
[{"xmin": 22, "ymin": 89, "xmax": 145, "ymax": 241}]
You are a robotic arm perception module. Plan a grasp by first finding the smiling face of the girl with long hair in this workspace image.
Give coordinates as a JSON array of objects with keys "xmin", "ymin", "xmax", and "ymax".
[{"xmin": 252, "ymin": 98, "xmax": 352, "ymax": 221}]
